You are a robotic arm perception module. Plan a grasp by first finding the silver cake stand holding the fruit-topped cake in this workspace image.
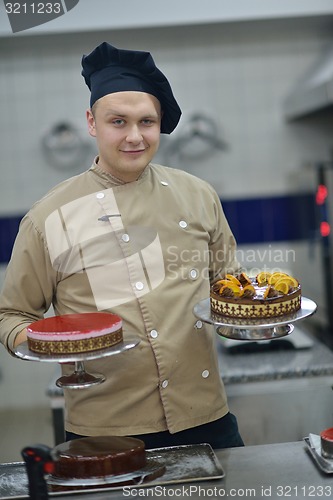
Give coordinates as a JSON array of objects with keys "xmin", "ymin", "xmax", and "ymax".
[{"xmin": 193, "ymin": 297, "xmax": 317, "ymax": 341}]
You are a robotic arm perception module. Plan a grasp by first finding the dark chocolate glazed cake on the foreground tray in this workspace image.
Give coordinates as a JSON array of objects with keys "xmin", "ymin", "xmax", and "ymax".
[{"xmin": 52, "ymin": 436, "xmax": 146, "ymax": 479}]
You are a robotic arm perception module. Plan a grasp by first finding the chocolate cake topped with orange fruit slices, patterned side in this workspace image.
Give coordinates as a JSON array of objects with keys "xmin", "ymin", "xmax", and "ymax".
[{"xmin": 210, "ymin": 271, "xmax": 301, "ymax": 319}]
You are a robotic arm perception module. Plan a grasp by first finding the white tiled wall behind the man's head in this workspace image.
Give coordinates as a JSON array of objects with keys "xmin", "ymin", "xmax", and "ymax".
[{"xmin": 0, "ymin": 21, "xmax": 333, "ymax": 213}]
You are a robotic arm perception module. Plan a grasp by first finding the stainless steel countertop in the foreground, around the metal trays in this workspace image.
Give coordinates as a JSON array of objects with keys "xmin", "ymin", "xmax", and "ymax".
[{"xmin": 46, "ymin": 441, "xmax": 333, "ymax": 500}]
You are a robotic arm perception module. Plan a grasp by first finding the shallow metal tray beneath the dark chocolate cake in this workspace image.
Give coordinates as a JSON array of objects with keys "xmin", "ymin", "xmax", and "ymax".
[{"xmin": 0, "ymin": 443, "xmax": 225, "ymax": 500}]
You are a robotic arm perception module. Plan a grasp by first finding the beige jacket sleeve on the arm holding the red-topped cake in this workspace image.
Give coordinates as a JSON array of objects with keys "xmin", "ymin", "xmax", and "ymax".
[{"xmin": 0, "ymin": 214, "xmax": 56, "ymax": 352}]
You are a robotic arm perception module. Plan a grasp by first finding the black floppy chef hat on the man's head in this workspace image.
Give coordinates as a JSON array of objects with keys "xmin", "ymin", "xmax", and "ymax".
[{"xmin": 82, "ymin": 42, "xmax": 181, "ymax": 134}]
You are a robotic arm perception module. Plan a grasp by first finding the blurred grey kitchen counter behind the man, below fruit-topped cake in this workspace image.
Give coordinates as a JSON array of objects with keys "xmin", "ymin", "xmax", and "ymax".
[{"xmin": 217, "ymin": 332, "xmax": 333, "ymax": 445}]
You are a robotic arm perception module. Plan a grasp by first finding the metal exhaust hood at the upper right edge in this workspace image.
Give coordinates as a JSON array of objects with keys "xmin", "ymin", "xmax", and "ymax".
[{"xmin": 284, "ymin": 46, "xmax": 333, "ymax": 120}]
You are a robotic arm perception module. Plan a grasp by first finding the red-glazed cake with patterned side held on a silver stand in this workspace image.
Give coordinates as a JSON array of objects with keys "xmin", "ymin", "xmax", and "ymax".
[{"xmin": 27, "ymin": 312, "xmax": 123, "ymax": 354}]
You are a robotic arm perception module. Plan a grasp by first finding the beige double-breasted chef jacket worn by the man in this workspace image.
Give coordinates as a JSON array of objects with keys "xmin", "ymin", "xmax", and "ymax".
[{"xmin": 0, "ymin": 160, "xmax": 239, "ymax": 436}]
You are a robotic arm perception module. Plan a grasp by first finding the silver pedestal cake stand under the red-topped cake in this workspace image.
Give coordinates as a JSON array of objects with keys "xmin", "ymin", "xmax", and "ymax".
[{"xmin": 15, "ymin": 337, "xmax": 140, "ymax": 389}]
